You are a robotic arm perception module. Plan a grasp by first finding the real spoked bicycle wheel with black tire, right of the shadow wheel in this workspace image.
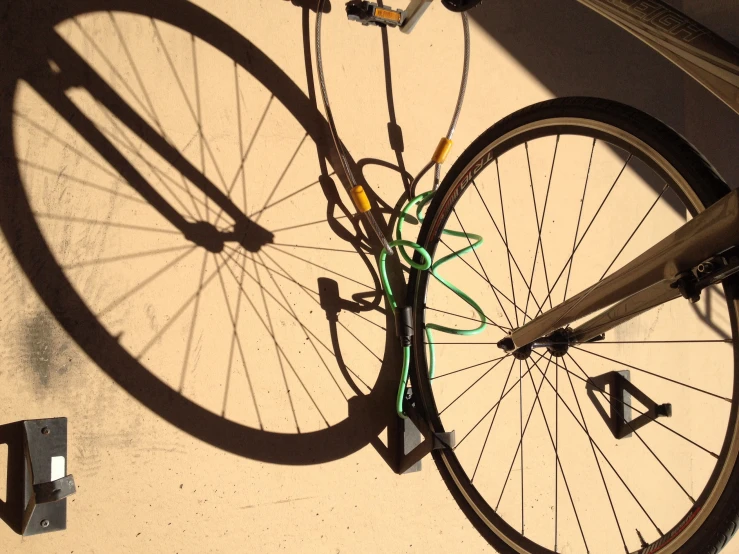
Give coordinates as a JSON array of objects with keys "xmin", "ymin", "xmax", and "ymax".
[{"xmin": 409, "ymin": 98, "xmax": 739, "ymax": 554}]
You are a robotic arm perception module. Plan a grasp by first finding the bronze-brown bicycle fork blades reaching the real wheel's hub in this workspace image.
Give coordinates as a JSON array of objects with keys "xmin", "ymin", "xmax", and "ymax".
[{"xmin": 510, "ymin": 190, "xmax": 739, "ymax": 348}]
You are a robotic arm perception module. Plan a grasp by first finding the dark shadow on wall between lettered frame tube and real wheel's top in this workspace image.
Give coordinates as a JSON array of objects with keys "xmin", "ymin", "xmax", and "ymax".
[{"xmin": 469, "ymin": 0, "xmax": 739, "ymax": 188}]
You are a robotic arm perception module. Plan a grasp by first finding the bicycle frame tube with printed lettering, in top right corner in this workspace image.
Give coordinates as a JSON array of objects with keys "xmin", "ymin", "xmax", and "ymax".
[{"xmin": 577, "ymin": 0, "xmax": 739, "ymax": 114}]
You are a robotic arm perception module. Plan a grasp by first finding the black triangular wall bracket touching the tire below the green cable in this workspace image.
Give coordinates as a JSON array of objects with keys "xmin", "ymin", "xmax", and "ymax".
[{"xmin": 397, "ymin": 387, "xmax": 455, "ymax": 475}]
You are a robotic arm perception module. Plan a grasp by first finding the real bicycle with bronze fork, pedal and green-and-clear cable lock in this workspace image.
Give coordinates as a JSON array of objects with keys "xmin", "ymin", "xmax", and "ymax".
[{"xmin": 316, "ymin": 0, "xmax": 739, "ymax": 554}]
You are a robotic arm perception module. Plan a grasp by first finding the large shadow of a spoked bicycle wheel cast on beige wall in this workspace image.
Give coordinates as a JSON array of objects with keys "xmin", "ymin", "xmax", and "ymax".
[{"xmin": 0, "ymin": 0, "xmax": 393, "ymax": 464}]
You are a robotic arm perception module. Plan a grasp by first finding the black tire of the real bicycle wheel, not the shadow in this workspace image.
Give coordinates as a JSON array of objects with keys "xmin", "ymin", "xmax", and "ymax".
[{"xmin": 407, "ymin": 97, "xmax": 739, "ymax": 554}]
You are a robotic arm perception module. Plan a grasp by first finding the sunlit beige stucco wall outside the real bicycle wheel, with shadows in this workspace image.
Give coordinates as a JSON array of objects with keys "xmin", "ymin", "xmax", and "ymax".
[{"xmin": 0, "ymin": 0, "xmax": 739, "ymax": 554}]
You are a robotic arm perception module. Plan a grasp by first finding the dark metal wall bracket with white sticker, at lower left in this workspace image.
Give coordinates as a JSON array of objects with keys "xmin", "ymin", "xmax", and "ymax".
[{"xmin": 20, "ymin": 417, "xmax": 76, "ymax": 536}]
